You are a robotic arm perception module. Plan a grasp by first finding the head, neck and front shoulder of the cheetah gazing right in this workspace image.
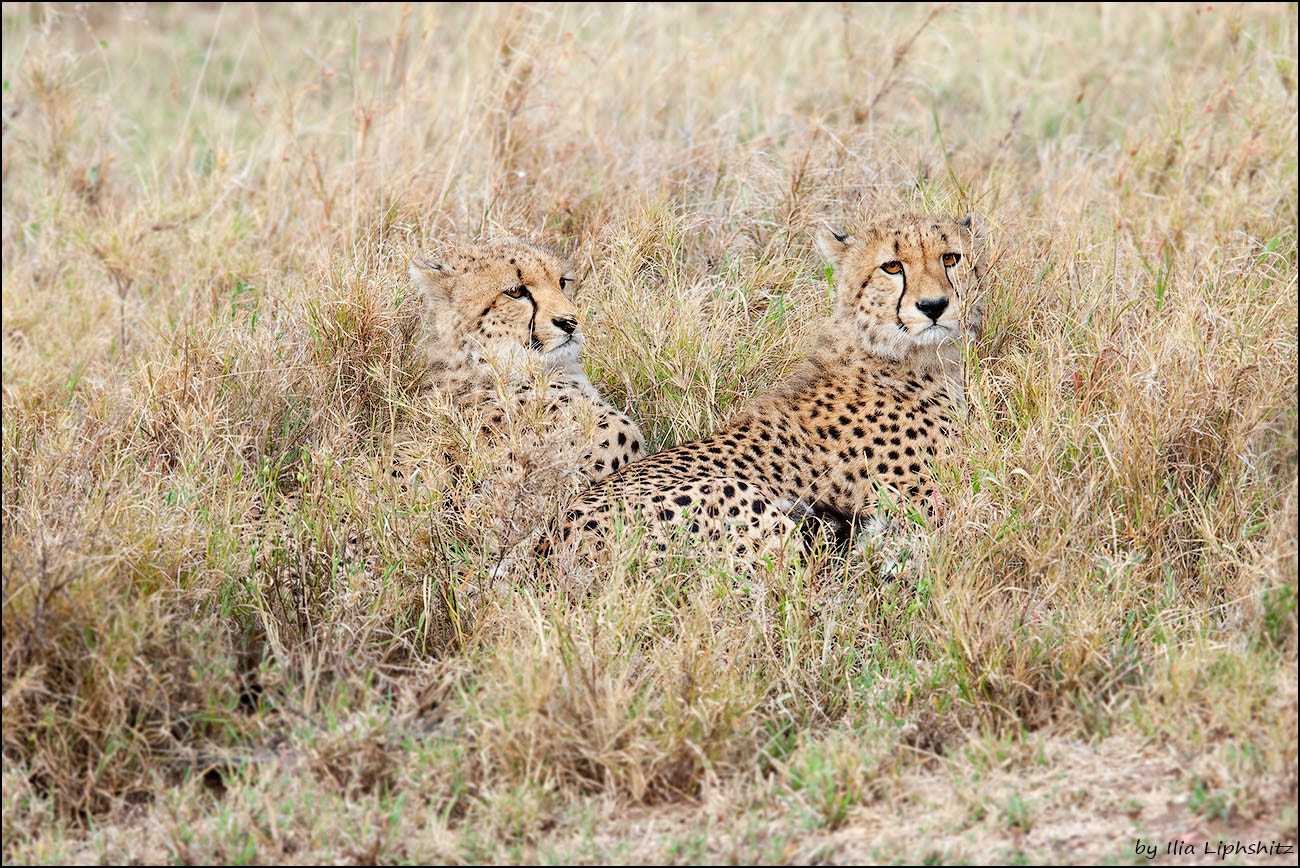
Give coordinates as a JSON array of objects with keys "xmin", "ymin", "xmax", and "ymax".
[{"xmin": 395, "ymin": 239, "xmax": 645, "ymax": 479}]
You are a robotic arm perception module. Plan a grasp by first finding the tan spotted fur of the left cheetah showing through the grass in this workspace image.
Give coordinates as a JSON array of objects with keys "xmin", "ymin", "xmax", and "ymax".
[{"xmin": 259, "ymin": 239, "xmax": 645, "ymax": 589}]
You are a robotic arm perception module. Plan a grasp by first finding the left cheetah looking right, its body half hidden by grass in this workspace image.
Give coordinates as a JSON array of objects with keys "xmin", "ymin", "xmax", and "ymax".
[{"xmin": 259, "ymin": 239, "xmax": 645, "ymax": 587}]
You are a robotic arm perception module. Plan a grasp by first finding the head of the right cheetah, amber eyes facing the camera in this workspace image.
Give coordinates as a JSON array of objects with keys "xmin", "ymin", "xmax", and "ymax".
[{"xmin": 816, "ymin": 213, "xmax": 984, "ymax": 357}]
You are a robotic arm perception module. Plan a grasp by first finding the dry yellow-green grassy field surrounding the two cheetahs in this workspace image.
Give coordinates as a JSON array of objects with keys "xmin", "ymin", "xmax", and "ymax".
[{"xmin": 3, "ymin": 3, "xmax": 1297, "ymax": 863}]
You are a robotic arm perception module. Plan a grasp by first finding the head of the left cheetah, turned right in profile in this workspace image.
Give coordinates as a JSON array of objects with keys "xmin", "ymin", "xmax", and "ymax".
[{"xmin": 410, "ymin": 238, "xmax": 582, "ymax": 368}]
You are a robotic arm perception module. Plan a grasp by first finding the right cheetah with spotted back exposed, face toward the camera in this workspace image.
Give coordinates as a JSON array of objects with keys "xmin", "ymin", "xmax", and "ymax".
[{"xmin": 562, "ymin": 214, "xmax": 985, "ymax": 552}]
